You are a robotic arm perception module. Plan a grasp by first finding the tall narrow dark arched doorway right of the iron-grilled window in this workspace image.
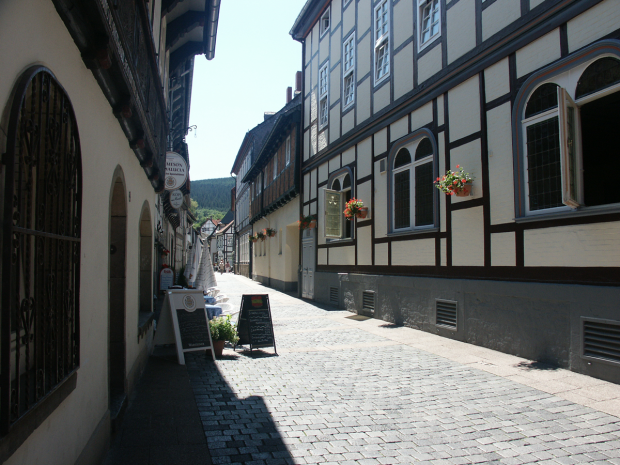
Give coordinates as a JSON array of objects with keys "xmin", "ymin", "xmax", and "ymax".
[{"xmin": 108, "ymin": 167, "xmax": 127, "ymax": 420}]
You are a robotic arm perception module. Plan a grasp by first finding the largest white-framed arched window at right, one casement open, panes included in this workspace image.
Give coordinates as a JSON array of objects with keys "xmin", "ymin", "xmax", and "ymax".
[{"xmin": 517, "ymin": 55, "xmax": 620, "ymax": 215}]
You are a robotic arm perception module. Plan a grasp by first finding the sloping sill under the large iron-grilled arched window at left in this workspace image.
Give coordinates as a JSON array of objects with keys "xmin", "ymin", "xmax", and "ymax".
[{"xmin": 0, "ymin": 368, "xmax": 77, "ymax": 463}]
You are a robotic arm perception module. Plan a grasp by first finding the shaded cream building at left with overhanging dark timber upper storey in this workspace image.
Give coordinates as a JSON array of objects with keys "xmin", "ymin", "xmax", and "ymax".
[{"xmin": 0, "ymin": 0, "xmax": 219, "ymax": 465}]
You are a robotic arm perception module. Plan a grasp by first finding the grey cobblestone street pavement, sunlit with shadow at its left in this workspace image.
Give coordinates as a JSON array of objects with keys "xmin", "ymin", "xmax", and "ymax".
[{"xmin": 187, "ymin": 275, "xmax": 620, "ymax": 465}]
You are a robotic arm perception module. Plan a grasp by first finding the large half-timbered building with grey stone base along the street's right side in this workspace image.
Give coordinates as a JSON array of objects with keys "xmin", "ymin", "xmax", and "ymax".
[{"xmin": 291, "ymin": 0, "xmax": 620, "ymax": 382}]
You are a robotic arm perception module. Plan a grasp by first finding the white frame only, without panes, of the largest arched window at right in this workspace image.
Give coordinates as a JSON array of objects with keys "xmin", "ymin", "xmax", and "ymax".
[{"xmin": 518, "ymin": 54, "xmax": 620, "ymax": 217}]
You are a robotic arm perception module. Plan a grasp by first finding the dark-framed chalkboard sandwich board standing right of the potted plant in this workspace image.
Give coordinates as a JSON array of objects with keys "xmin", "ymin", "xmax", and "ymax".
[{"xmin": 235, "ymin": 294, "xmax": 278, "ymax": 354}]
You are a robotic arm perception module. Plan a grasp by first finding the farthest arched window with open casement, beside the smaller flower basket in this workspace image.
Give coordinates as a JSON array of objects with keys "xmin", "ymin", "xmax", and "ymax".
[{"xmin": 323, "ymin": 169, "xmax": 354, "ymax": 239}]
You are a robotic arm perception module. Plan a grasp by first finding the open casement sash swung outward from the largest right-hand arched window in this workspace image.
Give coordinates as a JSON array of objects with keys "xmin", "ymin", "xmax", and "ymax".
[{"xmin": 558, "ymin": 86, "xmax": 581, "ymax": 208}]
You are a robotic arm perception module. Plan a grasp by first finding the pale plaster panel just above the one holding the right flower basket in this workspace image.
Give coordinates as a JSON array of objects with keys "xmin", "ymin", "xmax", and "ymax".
[{"xmin": 448, "ymin": 76, "xmax": 480, "ymax": 141}]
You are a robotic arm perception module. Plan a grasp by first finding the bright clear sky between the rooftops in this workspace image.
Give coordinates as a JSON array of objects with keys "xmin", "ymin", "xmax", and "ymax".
[{"xmin": 186, "ymin": 0, "xmax": 306, "ymax": 181}]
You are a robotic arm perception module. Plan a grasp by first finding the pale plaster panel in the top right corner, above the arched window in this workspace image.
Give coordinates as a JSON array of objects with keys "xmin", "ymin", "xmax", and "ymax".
[{"xmin": 566, "ymin": 0, "xmax": 620, "ymax": 52}]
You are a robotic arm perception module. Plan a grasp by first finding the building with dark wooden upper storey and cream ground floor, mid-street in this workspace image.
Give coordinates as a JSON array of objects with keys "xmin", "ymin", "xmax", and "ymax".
[{"xmin": 242, "ymin": 89, "xmax": 301, "ymax": 292}]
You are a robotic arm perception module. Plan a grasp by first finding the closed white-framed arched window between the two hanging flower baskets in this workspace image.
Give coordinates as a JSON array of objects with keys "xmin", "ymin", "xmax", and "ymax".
[{"xmin": 388, "ymin": 132, "xmax": 437, "ymax": 232}]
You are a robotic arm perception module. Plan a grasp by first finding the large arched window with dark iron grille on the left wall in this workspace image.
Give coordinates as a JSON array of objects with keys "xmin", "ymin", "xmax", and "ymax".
[{"xmin": 0, "ymin": 67, "xmax": 82, "ymax": 432}]
